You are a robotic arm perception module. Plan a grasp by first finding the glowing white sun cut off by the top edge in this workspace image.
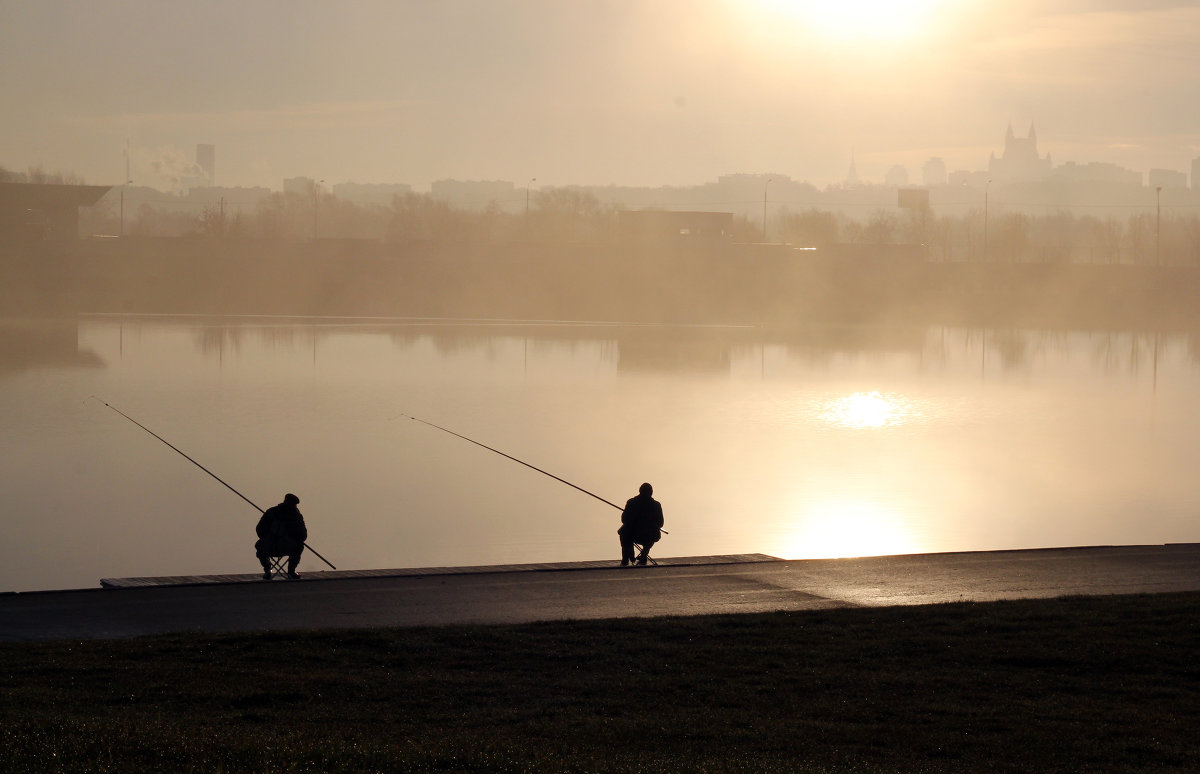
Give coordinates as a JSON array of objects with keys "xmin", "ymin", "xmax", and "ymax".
[{"xmin": 757, "ymin": 0, "xmax": 946, "ymax": 42}]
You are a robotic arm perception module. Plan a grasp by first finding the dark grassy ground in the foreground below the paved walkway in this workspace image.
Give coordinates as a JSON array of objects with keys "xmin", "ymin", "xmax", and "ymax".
[{"xmin": 0, "ymin": 593, "xmax": 1200, "ymax": 773}]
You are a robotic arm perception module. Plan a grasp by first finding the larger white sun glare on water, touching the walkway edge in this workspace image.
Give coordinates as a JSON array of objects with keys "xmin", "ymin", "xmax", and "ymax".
[{"xmin": 779, "ymin": 502, "xmax": 920, "ymax": 559}]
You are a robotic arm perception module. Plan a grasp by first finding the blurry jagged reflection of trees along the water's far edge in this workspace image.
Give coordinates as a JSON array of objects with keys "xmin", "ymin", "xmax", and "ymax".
[{"xmin": 91, "ymin": 317, "xmax": 1200, "ymax": 378}]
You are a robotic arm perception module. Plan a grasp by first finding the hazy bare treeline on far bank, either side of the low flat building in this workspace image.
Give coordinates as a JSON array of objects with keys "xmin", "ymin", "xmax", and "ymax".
[{"xmin": 82, "ymin": 187, "xmax": 1200, "ymax": 266}]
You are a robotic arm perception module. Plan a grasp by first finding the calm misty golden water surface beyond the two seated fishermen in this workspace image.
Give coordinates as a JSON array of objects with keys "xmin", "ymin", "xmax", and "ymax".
[{"xmin": 0, "ymin": 317, "xmax": 1200, "ymax": 590}]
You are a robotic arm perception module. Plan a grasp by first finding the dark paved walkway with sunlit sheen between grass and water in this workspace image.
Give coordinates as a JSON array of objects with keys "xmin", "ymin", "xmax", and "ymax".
[{"xmin": 0, "ymin": 544, "xmax": 1200, "ymax": 641}]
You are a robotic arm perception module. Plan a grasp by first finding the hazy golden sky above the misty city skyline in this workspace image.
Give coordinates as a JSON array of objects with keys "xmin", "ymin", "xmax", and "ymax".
[{"xmin": 0, "ymin": 0, "xmax": 1200, "ymax": 190}]
